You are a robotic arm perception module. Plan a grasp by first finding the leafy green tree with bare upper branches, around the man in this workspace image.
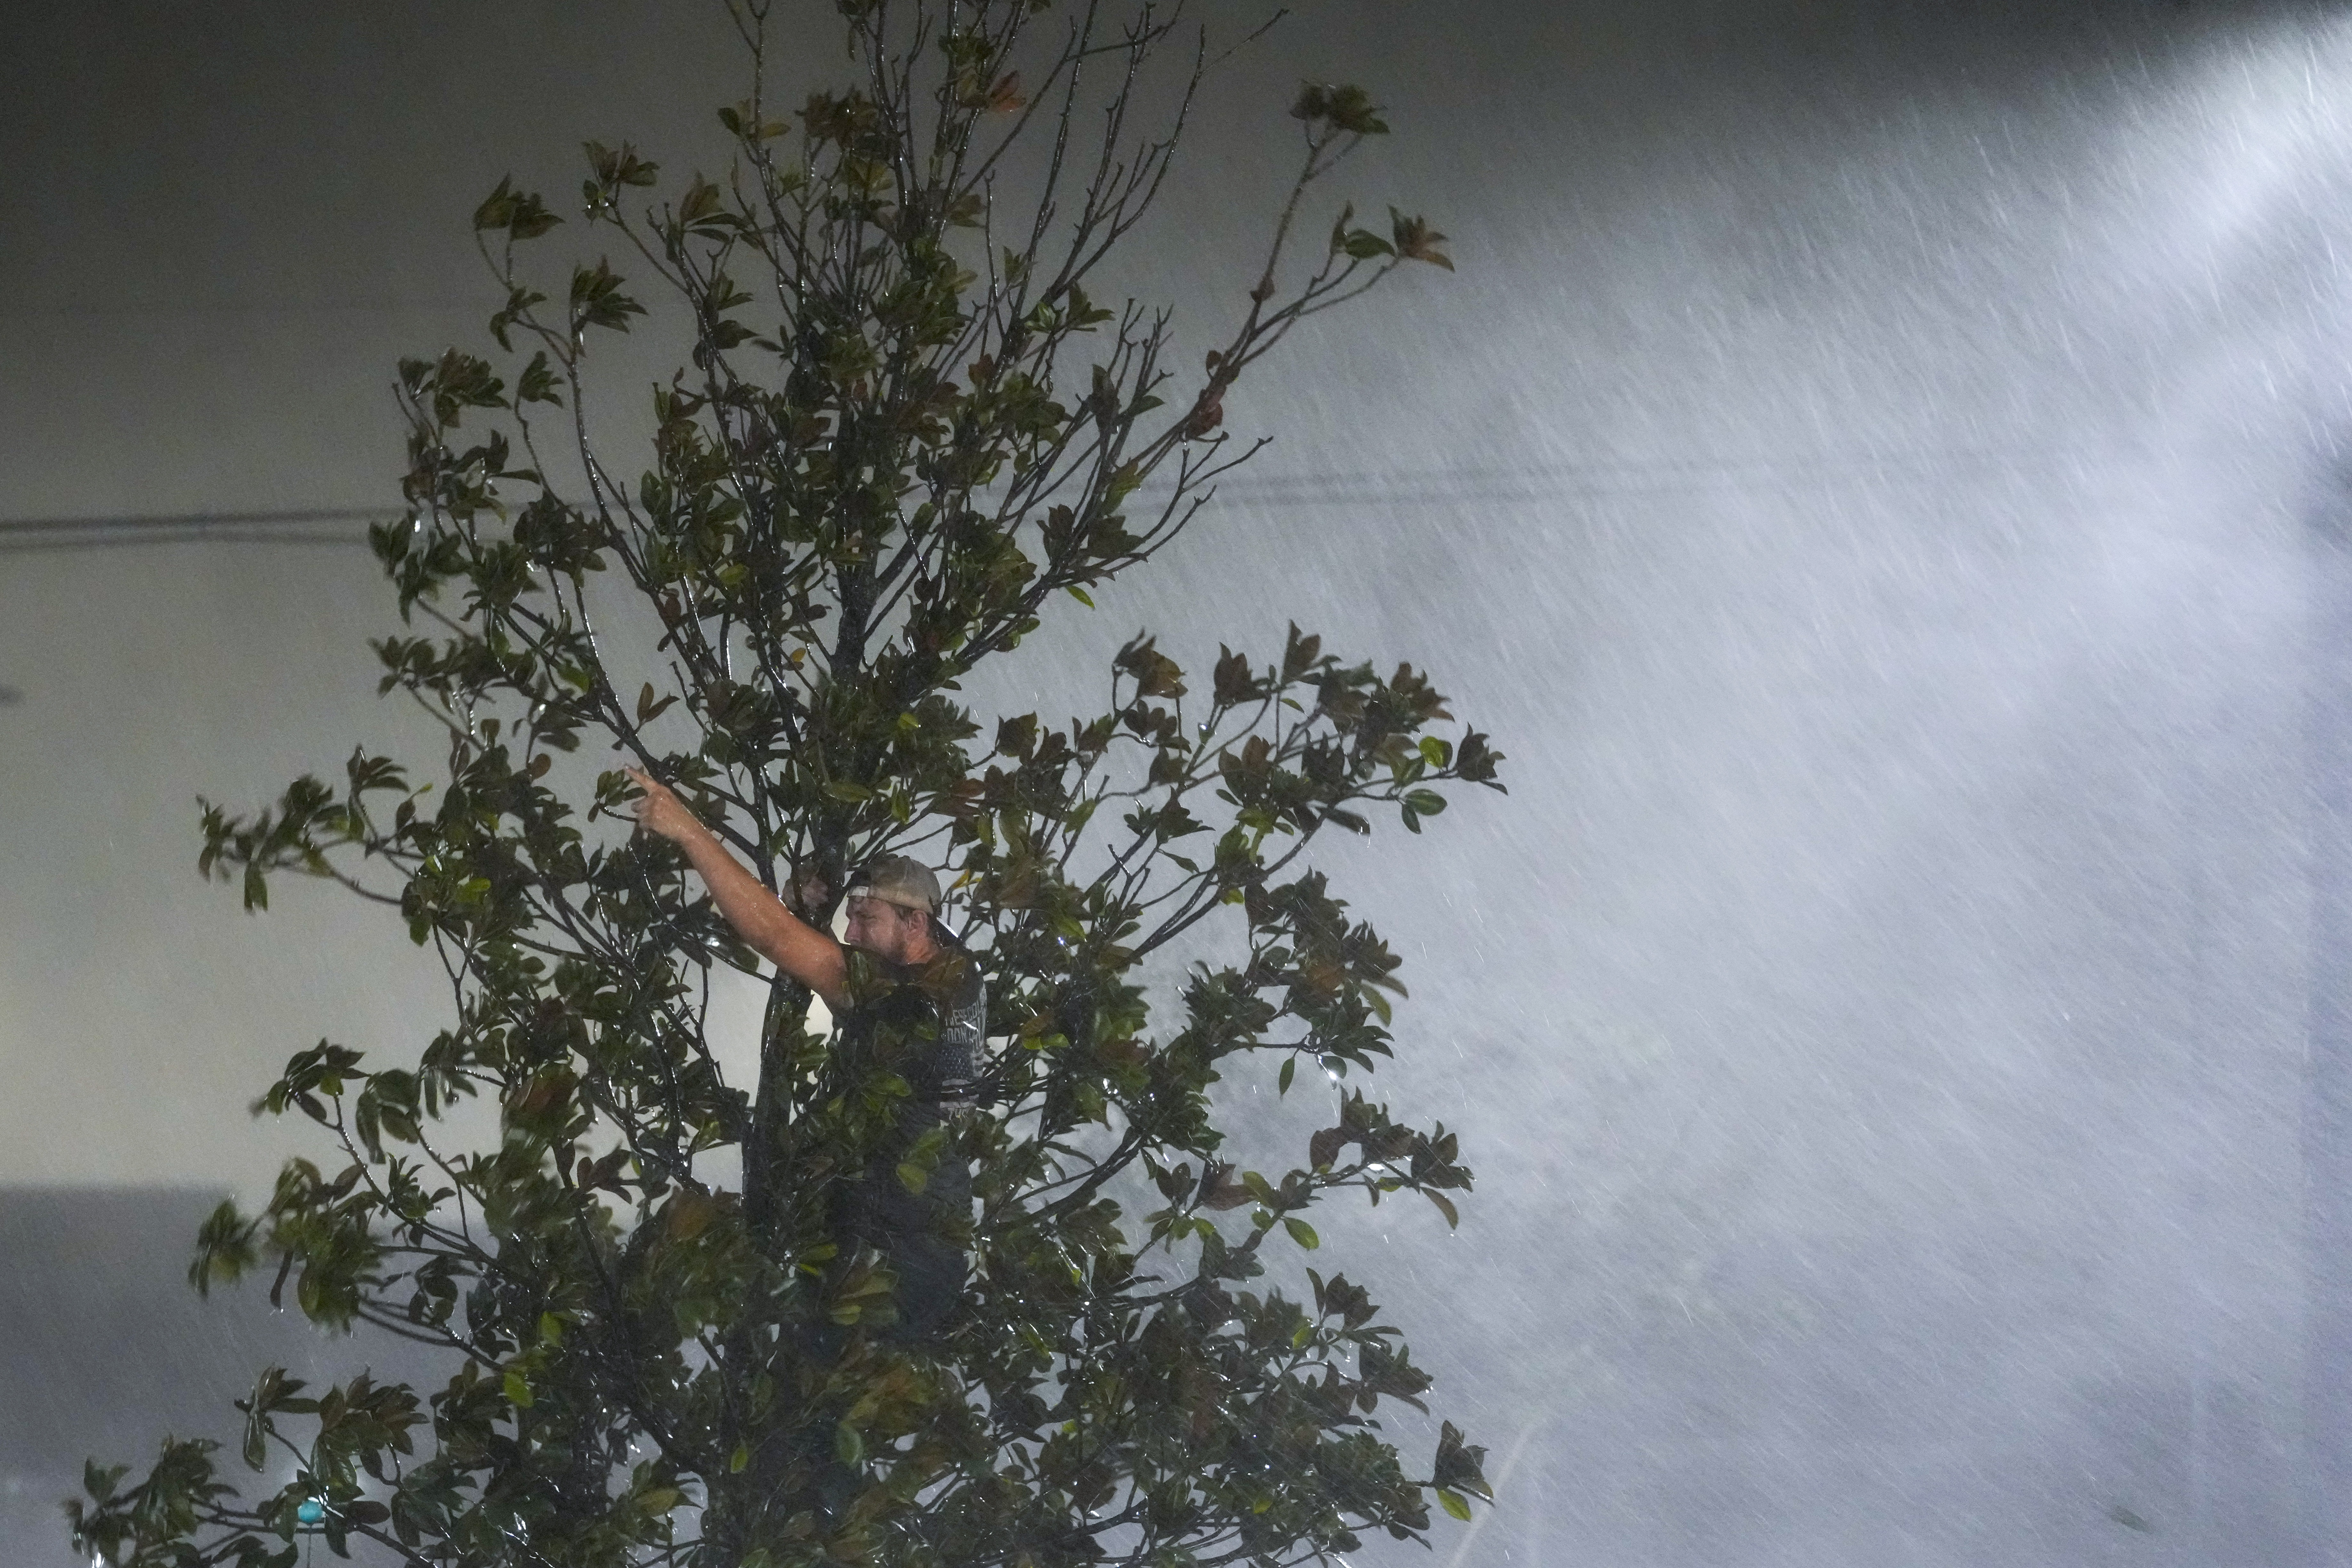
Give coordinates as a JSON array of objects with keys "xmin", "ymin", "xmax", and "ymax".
[{"xmin": 68, "ymin": 0, "xmax": 1501, "ymax": 1568}]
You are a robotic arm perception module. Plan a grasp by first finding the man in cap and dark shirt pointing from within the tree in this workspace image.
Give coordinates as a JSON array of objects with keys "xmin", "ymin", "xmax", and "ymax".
[{"xmin": 628, "ymin": 769, "xmax": 985, "ymax": 1340}]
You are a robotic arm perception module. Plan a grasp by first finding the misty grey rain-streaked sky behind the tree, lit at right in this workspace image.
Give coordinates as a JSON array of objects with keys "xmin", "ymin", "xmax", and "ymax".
[{"xmin": 0, "ymin": 0, "xmax": 2352, "ymax": 1568}]
